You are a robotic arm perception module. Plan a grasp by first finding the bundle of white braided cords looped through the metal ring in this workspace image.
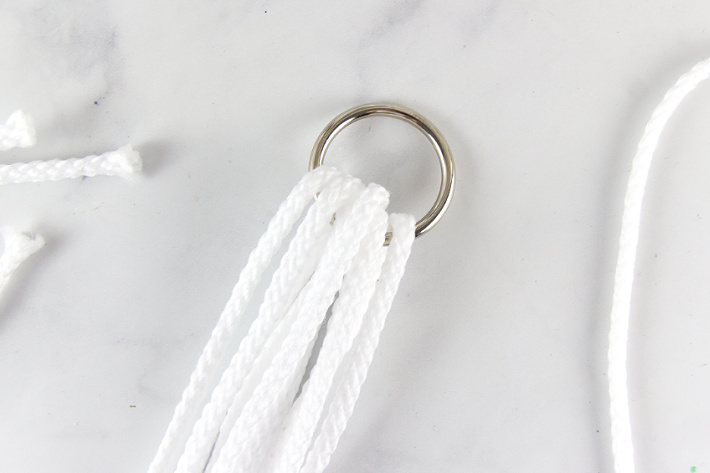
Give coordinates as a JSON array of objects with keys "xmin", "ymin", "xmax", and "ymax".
[{"xmin": 149, "ymin": 167, "xmax": 414, "ymax": 473}]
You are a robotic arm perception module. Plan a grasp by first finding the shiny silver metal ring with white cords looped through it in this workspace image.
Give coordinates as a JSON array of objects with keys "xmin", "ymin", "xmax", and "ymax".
[{"xmin": 308, "ymin": 103, "xmax": 454, "ymax": 244}]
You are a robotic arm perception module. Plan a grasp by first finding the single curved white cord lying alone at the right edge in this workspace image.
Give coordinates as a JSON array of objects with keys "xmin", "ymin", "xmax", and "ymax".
[{"xmin": 608, "ymin": 55, "xmax": 710, "ymax": 473}]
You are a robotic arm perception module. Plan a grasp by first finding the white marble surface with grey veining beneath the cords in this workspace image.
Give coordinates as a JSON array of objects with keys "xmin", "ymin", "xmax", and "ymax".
[{"xmin": 0, "ymin": 0, "xmax": 710, "ymax": 473}]
